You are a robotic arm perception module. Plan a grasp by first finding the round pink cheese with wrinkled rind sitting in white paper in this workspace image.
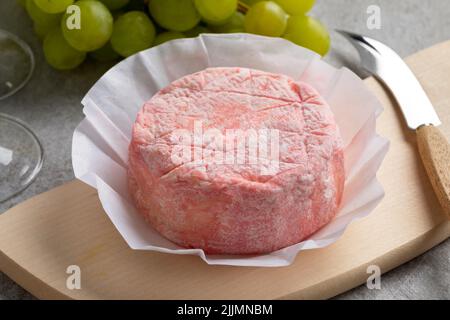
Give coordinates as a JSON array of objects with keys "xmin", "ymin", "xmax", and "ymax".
[{"xmin": 128, "ymin": 68, "xmax": 345, "ymax": 254}]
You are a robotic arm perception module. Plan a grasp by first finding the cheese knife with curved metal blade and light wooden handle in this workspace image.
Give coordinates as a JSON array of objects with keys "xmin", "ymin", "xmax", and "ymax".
[{"xmin": 336, "ymin": 30, "xmax": 450, "ymax": 217}]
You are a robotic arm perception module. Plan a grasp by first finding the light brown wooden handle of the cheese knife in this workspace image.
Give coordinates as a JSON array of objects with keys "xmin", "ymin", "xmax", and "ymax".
[{"xmin": 417, "ymin": 125, "xmax": 450, "ymax": 218}]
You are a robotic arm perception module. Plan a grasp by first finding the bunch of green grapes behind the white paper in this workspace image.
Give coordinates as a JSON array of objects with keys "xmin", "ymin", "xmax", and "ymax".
[{"xmin": 17, "ymin": 0, "xmax": 330, "ymax": 70}]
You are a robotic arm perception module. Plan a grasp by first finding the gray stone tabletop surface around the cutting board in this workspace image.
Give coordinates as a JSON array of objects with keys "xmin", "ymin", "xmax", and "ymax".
[{"xmin": 0, "ymin": 0, "xmax": 450, "ymax": 299}]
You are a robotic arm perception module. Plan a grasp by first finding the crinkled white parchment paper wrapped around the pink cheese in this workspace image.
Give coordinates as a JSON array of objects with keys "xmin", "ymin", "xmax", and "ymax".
[{"xmin": 72, "ymin": 34, "xmax": 389, "ymax": 267}]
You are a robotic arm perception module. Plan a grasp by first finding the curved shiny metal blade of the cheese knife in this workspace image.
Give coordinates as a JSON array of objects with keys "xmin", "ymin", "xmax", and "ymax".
[{"xmin": 336, "ymin": 30, "xmax": 441, "ymax": 130}]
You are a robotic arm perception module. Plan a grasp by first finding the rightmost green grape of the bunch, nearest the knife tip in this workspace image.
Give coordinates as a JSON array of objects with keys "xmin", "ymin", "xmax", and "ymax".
[{"xmin": 284, "ymin": 16, "xmax": 330, "ymax": 56}]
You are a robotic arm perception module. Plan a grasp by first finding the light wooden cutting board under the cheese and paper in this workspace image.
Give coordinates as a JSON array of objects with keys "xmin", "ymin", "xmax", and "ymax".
[{"xmin": 0, "ymin": 42, "xmax": 450, "ymax": 299}]
